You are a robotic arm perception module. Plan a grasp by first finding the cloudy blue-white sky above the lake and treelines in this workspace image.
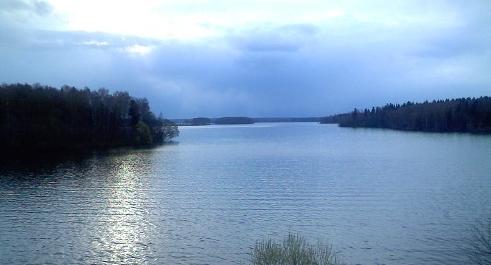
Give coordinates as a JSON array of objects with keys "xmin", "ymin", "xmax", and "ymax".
[{"xmin": 0, "ymin": 0, "xmax": 491, "ymax": 118}]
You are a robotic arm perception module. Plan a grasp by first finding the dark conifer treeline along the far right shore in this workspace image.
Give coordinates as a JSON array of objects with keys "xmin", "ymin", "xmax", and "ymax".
[{"xmin": 321, "ymin": 97, "xmax": 491, "ymax": 133}]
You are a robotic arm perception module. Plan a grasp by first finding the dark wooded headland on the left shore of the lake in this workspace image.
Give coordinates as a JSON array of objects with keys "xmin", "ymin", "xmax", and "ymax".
[{"xmin": 0, "ymin": 84, "xmax": 179, "ymax": 152}]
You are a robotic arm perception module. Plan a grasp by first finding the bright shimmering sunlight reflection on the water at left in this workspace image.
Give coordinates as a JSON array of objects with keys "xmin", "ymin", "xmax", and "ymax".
[{"xmin": 88, "ymin": 153, "xmax": 155, "ymax": 264}]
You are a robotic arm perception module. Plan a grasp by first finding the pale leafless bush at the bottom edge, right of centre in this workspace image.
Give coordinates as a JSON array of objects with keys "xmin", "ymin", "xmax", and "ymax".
[{"xmin": 251, "ymin": 234, "xmax": 341, "ymax": 265}]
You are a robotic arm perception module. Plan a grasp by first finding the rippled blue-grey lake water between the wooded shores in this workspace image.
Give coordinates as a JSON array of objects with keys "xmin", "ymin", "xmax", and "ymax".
[{"xmin": 0, "ymin": 123, "xmax": 491, "ymax": 264}]
